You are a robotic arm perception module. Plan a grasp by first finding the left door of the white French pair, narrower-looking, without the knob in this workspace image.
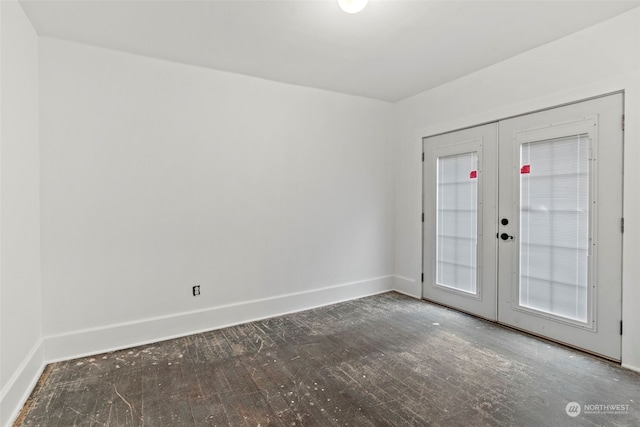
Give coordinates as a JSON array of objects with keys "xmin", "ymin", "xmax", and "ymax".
[{"xmin": 423, "ymin": 123, "xmax": 497, "ymax": 320}]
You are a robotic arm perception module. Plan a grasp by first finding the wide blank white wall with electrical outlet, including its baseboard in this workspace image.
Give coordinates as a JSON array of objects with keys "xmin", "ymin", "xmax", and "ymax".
[{"xmin": 40, "ymin": 38, "xmax": 394, "ymax": 359}]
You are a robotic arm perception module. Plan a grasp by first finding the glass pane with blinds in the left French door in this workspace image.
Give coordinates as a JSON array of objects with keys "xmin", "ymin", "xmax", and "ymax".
[{"xmin": 436, "ymin": 153, "xmax": 478, "ymax": 294}]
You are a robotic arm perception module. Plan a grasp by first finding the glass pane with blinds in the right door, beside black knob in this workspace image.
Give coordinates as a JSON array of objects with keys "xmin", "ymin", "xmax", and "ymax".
[{"xmin": 519, "ymin": 135, "xmax": 589, "ymax": 322}]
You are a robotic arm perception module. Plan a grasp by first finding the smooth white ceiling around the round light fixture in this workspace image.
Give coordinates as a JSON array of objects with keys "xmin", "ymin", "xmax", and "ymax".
[{"xmin": 21, "ymin": 0, "xmax": 640, "ymax": 101}]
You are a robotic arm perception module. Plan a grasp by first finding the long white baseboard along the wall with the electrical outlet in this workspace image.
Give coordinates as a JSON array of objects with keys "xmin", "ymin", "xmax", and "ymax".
[{"xmin": 44, "ymin": 275, "xmax": 394, "ymax": 363}]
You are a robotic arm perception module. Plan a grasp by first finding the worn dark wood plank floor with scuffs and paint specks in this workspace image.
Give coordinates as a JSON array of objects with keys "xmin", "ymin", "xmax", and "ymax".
[{"xmin": 16, "ymin": 293, "xmax": 640, "ymax": 427}]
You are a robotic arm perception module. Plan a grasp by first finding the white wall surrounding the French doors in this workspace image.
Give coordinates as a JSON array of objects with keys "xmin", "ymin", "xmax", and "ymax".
[{"xmin": 395, "ymin": 8, "xmax": 640, "ymax": 370}]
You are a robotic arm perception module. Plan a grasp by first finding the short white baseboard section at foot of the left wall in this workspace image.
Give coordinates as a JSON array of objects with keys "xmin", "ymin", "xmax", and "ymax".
[{"xmin": 0, "ymin": 340, "xmax": 45, "ymax": 427}]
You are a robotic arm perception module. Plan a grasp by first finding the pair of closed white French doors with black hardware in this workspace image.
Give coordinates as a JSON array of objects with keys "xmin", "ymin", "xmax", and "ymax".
[{"xmin": 423, "ymin": 94, "xmax": 623, "ymax": 360}]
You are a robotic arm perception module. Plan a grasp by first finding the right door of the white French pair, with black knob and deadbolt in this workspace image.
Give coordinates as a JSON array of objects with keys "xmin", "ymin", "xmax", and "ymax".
[{"xmin": 498, "ymin": 94, "xmax": 623, "ymax": 360}]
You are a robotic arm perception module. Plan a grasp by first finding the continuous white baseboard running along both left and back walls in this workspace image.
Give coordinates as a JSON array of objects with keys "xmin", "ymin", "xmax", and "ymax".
[{"xmin": 5, "ymin": 275, "xmax": 400, "ymax": 427}]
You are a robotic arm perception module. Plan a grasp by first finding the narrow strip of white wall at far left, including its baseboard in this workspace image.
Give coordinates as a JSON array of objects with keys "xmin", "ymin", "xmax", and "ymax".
[{"xmin": 0, "ymin": 1, "xmax": 43, "ymax": 425}]
